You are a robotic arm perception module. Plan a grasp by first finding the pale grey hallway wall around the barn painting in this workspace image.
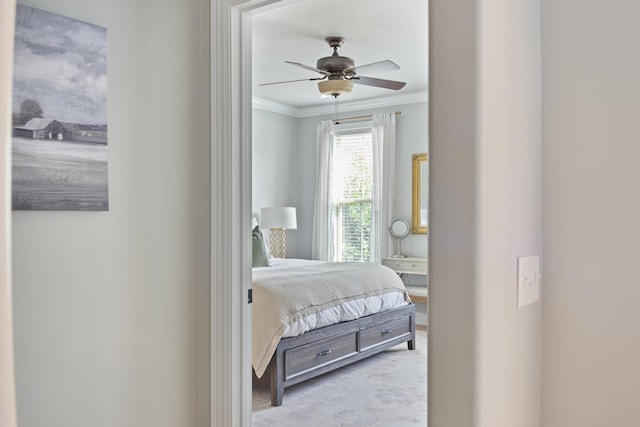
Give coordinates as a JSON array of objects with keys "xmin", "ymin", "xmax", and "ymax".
[{"xmin": 13, "ymin": 0, "xmax": 209, "ymax": 427}]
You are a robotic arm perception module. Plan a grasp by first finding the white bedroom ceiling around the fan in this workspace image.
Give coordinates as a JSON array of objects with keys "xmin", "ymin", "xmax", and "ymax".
[{"xmin": 252, "ymin": 0, "xmax": 428, "ymax": 115}]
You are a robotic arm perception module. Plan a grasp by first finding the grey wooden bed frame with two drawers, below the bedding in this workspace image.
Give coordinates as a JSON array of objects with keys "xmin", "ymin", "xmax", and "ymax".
[{"xmin": 264, "ymin": 304, "xmax": 416, "ymax": 406}]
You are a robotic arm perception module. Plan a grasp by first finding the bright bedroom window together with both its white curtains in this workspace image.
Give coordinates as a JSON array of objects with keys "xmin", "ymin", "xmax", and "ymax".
[{"xmin": 311, "ymin": 113, "xmax": 396, "ymax": 263}]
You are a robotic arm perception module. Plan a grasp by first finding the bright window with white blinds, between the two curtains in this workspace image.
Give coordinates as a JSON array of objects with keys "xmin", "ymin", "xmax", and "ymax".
[{"xmin": 331, "ymin": 130, "xmax": 373, "ymax": 262}]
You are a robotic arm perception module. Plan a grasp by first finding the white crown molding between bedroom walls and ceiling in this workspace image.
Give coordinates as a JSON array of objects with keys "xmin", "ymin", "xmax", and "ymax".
[{"xmin": 252, "ymin": 91, "xmax": 427, "ymax": 118}]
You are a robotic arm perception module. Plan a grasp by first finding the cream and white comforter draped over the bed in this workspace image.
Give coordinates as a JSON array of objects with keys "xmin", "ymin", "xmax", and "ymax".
[{"xmin": 253, "ymin": 259, "xmax": 410, "ymax": 377}]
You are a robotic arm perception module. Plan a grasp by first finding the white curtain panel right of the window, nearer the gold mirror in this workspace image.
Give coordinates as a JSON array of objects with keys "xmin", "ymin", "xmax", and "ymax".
[{"xmin": 371, "ymin": 113, "xmax": 396, "ymax": 263}]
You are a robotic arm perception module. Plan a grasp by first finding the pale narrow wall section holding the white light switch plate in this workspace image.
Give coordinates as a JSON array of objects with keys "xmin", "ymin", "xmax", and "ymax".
[{"xmin": 475, "ymin": 0, "xmax": 543, "ymax": 427}]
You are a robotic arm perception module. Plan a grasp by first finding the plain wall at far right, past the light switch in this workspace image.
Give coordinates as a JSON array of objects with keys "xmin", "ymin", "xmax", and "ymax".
[{"xmin": 541, "ymin": 0, "xmax": 640, "ymax": 427}]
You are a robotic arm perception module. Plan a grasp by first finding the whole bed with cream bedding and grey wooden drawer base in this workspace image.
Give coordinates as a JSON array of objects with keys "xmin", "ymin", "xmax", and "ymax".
[{"xmin": 252, "ymin": 258, "xmax": 415, "ymax": 406}]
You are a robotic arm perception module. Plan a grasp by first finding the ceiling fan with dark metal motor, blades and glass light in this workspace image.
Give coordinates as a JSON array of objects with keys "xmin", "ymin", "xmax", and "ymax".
[{"xmin": 260, "ymin": 36, "xmax": 406, "ymax": 98}]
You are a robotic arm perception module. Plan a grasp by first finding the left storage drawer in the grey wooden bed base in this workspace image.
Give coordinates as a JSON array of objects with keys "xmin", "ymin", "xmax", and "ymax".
[{"xmin": 284, "ymin": 331, "xmax": 358, "ymax": 380}]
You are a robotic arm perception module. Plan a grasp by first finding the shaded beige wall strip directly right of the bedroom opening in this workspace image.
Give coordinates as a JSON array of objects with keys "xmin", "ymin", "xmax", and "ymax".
[{"xmin": 428, "ymin": 0, "xmax": 476, "ymax": 427}]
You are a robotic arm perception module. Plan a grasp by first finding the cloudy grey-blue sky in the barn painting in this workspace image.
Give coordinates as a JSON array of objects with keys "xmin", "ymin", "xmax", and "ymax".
[{"xmin": 13, "ymin": 5, "xmax": 107, "ymax": 125}]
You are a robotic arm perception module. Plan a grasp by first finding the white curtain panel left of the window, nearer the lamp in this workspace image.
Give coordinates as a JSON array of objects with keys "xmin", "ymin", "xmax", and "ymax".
[{"xmin": 311, "ymin": 120, "xmax": 333, "ymax": 261}]
